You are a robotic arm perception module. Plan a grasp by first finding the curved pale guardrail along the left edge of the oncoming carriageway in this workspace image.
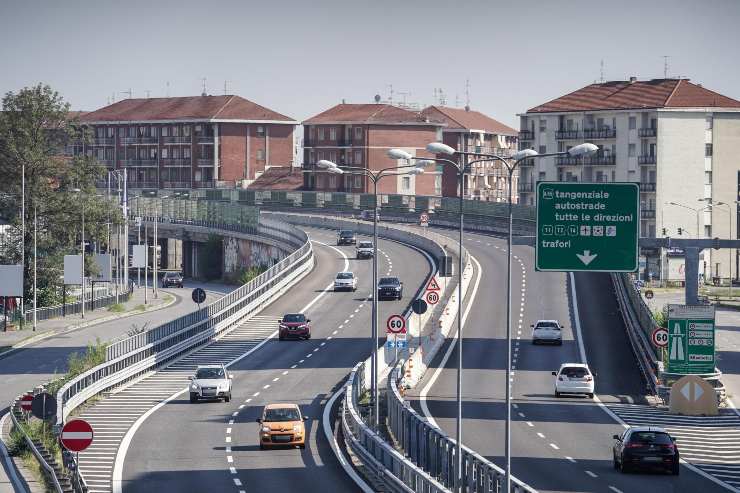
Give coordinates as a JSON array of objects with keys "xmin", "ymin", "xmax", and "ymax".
[{"xmin": 56, "ymin": 215, "xmax": 314, "ymax": 424}]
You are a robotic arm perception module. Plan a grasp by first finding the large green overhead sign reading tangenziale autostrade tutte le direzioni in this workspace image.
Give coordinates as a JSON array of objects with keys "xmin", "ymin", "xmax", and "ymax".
[{"xmin": 535, "ymin": 182, "xmax": 640, "ymax": 272}]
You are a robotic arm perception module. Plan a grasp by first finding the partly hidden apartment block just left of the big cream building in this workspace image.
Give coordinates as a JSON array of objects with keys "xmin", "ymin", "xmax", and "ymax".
[{"xmin": 421, "ymin": 106, "xmax": 519, "ymax": 202}]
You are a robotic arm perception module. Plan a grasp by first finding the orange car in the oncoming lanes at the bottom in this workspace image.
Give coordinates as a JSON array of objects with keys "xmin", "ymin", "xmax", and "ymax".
[{"xmin": 257, "ymin": 404, "xmax": 308, "ymax": 449}]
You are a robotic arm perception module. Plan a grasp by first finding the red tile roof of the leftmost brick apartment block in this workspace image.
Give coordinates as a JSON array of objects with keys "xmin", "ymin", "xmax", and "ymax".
[{"xmin": 81, "ymin": 96, "xmax": 293, "ymax": 123}]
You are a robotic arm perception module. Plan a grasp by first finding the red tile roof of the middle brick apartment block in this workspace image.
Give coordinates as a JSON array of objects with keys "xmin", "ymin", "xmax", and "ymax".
[{"xmin": 303, "ymin": 103, "xmax": 440, "ymax": 126}]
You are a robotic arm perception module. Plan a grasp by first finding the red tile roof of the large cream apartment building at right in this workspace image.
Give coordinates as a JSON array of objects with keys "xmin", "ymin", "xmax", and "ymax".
[{"xmin": 527, "ymin": 79, "xmax": 740, "ymax": 113}]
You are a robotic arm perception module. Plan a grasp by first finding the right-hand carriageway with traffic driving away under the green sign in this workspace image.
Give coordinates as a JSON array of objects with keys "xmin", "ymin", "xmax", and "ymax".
[{"xmin": 404, "ymin": 232, "xmax": 727, "ymax": 493}]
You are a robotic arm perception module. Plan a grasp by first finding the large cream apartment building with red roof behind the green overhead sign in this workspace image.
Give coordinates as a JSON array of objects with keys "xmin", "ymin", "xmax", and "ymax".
[{"xmin": 518, "ymin": 77, "xmax": 740, "ymax": 279}]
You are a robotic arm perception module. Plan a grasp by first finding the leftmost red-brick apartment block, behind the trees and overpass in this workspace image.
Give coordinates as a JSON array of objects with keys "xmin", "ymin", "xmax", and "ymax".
[{"xmin": 75, "ymin": 95, "xmax": 298, "ymax": 189}]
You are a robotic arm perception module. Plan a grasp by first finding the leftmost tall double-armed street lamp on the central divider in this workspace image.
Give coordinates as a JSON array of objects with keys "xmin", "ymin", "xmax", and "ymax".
[{"xmin": 316, "ymin": 160, "xmax": 424, "ymax": 430}]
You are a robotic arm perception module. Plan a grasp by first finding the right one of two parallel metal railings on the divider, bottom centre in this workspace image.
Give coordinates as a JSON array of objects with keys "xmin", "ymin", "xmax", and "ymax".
[{"xmin": 387, "ymin": 366, "xmax": 536, "ymax": 493}]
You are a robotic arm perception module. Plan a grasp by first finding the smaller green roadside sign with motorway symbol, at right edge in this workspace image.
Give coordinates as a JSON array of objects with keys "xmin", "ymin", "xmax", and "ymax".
[{"xmin": 666, "ymin": 305, "xmax": 715, "ymax": 375}]
